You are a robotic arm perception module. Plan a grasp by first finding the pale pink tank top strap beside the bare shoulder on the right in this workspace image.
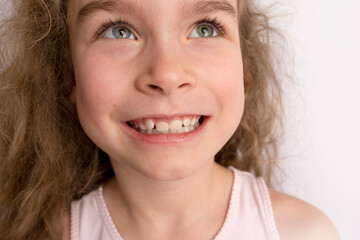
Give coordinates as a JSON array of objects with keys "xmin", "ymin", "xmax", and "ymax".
[{"xmin": 215, "ymin": 167, "xmax": 280, "ymax": 240}]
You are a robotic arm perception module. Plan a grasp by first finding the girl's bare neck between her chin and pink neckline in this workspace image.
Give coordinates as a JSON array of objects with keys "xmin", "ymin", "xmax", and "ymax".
[{"xmin": 104, "ymin": 161, "xmax": 232, "ymax": 236}]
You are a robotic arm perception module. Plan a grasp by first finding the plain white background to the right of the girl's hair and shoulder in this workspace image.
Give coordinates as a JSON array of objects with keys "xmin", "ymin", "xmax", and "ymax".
[{"xmin": 0, "ymin": 0, "xmax": 360, "ymax": 240}]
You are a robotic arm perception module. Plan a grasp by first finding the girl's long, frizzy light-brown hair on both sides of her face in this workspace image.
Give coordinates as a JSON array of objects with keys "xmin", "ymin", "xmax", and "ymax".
[{"xmin": 0, "ymin": 0, "xmax": 282, "ymax": 240}]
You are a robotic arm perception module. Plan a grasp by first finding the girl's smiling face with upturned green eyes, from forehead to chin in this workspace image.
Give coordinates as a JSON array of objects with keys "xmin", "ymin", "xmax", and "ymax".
[{"xmin": 69, "ymin": 0, "xmax": 244, "ymax": 180}]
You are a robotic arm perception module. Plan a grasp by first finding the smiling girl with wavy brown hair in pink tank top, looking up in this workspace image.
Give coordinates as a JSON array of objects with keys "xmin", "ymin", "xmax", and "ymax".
[{"xmin": 0, "ymin": 0, "xmax": 338, "ymax": 240}]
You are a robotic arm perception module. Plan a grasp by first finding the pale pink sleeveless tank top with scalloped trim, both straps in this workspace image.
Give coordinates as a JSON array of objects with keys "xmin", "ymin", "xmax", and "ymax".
[{"xmin": 71, "ymin": 167, "xmax": 280, "ymax": 240}]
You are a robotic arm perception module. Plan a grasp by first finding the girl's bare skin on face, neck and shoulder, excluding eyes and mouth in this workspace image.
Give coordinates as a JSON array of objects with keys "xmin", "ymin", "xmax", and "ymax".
[{"xmin": 64, "ymin": 0, "xmax": 336, "ymax": 239}]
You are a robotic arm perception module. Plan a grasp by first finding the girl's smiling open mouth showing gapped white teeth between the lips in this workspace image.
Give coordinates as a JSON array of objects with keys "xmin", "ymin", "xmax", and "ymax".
[{"xmin": 126, "ymin": 116, "xmax": 204, "ymax": 135}]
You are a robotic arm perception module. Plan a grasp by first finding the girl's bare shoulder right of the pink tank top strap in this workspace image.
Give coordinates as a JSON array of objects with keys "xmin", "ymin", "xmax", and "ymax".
[{"xmin": 269, "ymin": 189, "xmax": 340, "ymax": 240}]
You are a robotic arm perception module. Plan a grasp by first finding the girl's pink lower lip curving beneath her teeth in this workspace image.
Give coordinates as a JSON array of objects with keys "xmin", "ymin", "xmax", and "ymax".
[{"xmin": 122, "ymin": 117, "xmax": 209, "ymax": 144}]
